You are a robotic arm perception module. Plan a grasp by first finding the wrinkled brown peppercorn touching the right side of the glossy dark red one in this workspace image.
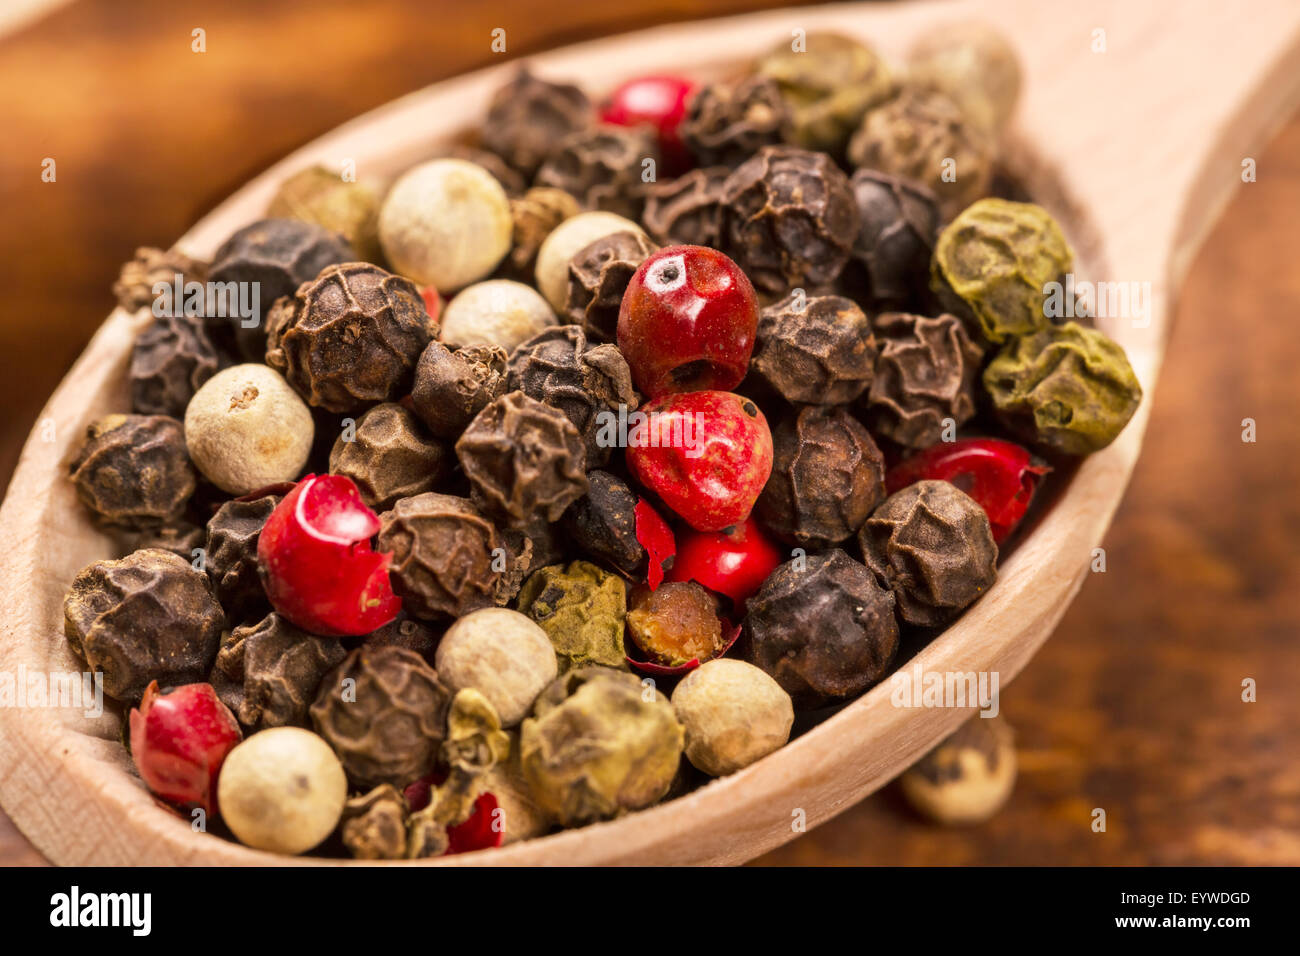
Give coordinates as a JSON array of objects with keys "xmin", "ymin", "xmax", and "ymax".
[{"xmin": 751, "ymin": 293, "xmax": 876, "ymax": 405}]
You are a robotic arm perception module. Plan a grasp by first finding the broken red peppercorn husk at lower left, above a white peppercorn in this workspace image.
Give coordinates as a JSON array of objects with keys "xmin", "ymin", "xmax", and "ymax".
[{"xmin": 129, "ymin": 680, "xmax": 243, "ymax": 813}]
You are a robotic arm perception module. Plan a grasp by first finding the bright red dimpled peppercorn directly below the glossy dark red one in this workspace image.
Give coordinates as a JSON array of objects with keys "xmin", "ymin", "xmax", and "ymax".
[{"xmin": 627, "ymin": 392, "xmax": 772, "ymax": 531}]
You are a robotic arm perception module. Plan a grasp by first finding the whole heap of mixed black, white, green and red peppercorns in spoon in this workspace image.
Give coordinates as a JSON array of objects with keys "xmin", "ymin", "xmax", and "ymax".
[{"xmin": 65, "ymin": 30, "xmax": 1141, "ymax": 860}]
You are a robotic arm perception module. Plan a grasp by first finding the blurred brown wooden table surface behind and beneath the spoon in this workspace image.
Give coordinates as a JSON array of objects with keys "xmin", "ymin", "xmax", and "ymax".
[{"xmin": 0, "ymin": 0, "xmax": 1300, "ymax": 865}]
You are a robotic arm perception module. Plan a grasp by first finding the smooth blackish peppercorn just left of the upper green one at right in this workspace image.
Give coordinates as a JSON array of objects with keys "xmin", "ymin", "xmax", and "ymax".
[{"xmin": 849, "ymin": 169, "xmax": 939, "ymax": 311}]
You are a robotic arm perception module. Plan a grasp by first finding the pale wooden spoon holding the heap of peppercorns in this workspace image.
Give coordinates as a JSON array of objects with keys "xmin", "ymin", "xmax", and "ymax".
[{"xmin": 0, "ymin": 0, "xmax": 1300, "ymax": 865}]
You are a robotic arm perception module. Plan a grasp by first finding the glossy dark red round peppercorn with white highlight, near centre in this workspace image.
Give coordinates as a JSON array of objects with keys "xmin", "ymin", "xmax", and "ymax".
[{"xmin": 618, "ymin": 246, "xmax": 758, "ymax": 398}]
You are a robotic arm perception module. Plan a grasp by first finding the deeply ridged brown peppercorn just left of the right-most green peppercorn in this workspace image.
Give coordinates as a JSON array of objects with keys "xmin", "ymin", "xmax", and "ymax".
[{"xmin": 866, "ymin": 312, "xmax": 984, "ymax": 449}]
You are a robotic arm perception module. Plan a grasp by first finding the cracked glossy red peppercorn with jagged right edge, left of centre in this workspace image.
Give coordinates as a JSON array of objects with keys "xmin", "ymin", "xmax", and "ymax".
[{"xmin": 257, "ymin": 475, "xmax": 402, "ymax": 637}]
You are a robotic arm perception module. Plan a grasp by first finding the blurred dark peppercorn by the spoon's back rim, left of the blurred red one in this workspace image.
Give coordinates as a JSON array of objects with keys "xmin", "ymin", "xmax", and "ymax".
[{"xmin": 482, "ymin": 69, "xmax": 595, "ymax": 179}]
